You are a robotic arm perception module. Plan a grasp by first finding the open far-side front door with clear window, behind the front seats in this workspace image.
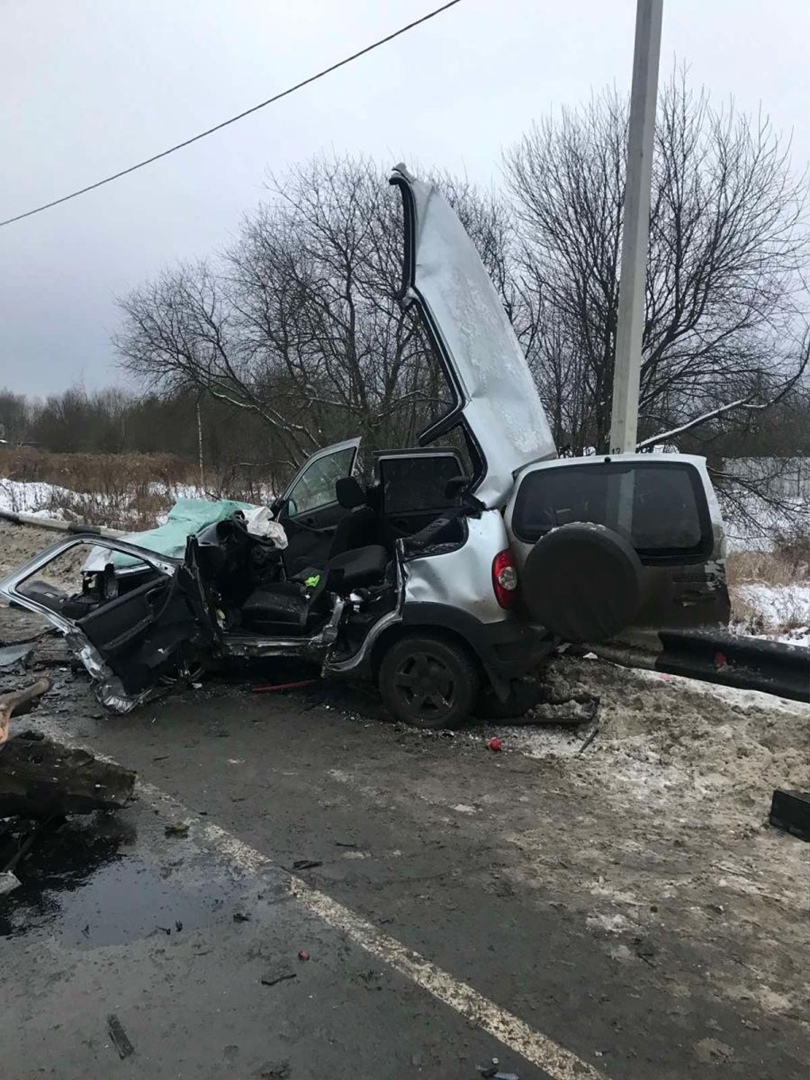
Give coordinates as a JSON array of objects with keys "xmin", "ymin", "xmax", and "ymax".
[{"xmin": 278, "ymin": 438, "xmax": 361, "ymax": 575}]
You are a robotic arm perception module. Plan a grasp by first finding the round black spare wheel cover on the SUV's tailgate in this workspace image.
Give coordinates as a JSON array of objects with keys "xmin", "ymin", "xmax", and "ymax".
[{"xmin": 521, "ymin": 522, "xmax": 643, "ymax": 643}]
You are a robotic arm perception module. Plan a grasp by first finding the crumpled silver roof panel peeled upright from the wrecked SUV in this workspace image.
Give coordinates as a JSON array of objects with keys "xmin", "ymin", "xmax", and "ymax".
[{"xmin": 391, "ymin": 165, "xmax": 556, "ymax": 507}]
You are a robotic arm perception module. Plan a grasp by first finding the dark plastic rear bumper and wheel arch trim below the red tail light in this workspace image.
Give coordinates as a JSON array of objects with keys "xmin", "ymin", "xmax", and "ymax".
[{"xmin": 402, "ymin": 603, "xmax": 557, "ymax": 680}]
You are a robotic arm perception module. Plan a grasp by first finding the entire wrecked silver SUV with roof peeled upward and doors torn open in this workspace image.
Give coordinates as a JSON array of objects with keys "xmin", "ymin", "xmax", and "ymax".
[{"xmin": 0, "ymin": 166, "xmax": 729, "ymax": 728}]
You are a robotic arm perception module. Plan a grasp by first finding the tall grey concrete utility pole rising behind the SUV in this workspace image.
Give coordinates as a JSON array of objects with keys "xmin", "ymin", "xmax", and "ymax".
[{"xmin": 610, "ymin": 0, "xmax": 663, "ymax": 454}]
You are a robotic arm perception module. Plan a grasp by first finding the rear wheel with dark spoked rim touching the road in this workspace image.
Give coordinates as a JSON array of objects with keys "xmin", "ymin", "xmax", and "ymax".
[{"xmin": 378, "ymin": 634, "xmax": 481, "ymax": 731}]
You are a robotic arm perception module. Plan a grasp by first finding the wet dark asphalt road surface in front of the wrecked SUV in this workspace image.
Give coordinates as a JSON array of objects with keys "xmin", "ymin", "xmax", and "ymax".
[{"xmin": 0, "ymin": 622, "xmax": 810, "ymax": 1080}]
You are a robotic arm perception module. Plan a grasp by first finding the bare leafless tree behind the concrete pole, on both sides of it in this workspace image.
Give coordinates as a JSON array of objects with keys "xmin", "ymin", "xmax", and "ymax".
[{"xmin": 505, "ymin": 73, "xmax": 808, "ymax": 449}]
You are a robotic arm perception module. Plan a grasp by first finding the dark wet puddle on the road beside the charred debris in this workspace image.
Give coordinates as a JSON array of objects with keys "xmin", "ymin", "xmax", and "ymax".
[{"xmin": 0, "ymin": 818, "xmax": 244, "ymax": 948}]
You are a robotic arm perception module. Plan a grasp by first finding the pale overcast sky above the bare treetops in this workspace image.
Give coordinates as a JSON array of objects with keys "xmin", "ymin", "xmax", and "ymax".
[{"xmin": 0, "ymin": 0, "xmax": 810, "ymax": 395}]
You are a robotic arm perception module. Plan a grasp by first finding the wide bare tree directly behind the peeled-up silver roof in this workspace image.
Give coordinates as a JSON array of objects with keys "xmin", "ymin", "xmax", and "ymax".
[{"xmin": 116, "ymin": 158, "xmax": 512, "ymax": 463}]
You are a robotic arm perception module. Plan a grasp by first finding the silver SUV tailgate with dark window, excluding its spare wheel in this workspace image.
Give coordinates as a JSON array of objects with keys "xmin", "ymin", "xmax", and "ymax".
[{"xmin": 505, "ymin": 454, "xmax": 730, "ymax": 629}]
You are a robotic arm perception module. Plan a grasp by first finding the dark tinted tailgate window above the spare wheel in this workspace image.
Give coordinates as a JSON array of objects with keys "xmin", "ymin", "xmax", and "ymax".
[{"xmin": 512, "ymin": 461, "xmax": 713, "ymax": 559}]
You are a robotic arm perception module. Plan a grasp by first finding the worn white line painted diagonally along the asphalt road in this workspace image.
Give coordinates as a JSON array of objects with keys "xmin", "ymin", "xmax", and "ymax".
[{"xmin": 25, "ymin": 721, "xmax": 608, "ymax": 1080}]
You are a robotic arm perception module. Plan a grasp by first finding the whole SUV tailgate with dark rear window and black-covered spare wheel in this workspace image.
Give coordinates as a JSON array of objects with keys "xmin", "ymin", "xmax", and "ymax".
[{"xmin": 505, "ymin": 454, "xmax": 730, "ymax": 642}]
